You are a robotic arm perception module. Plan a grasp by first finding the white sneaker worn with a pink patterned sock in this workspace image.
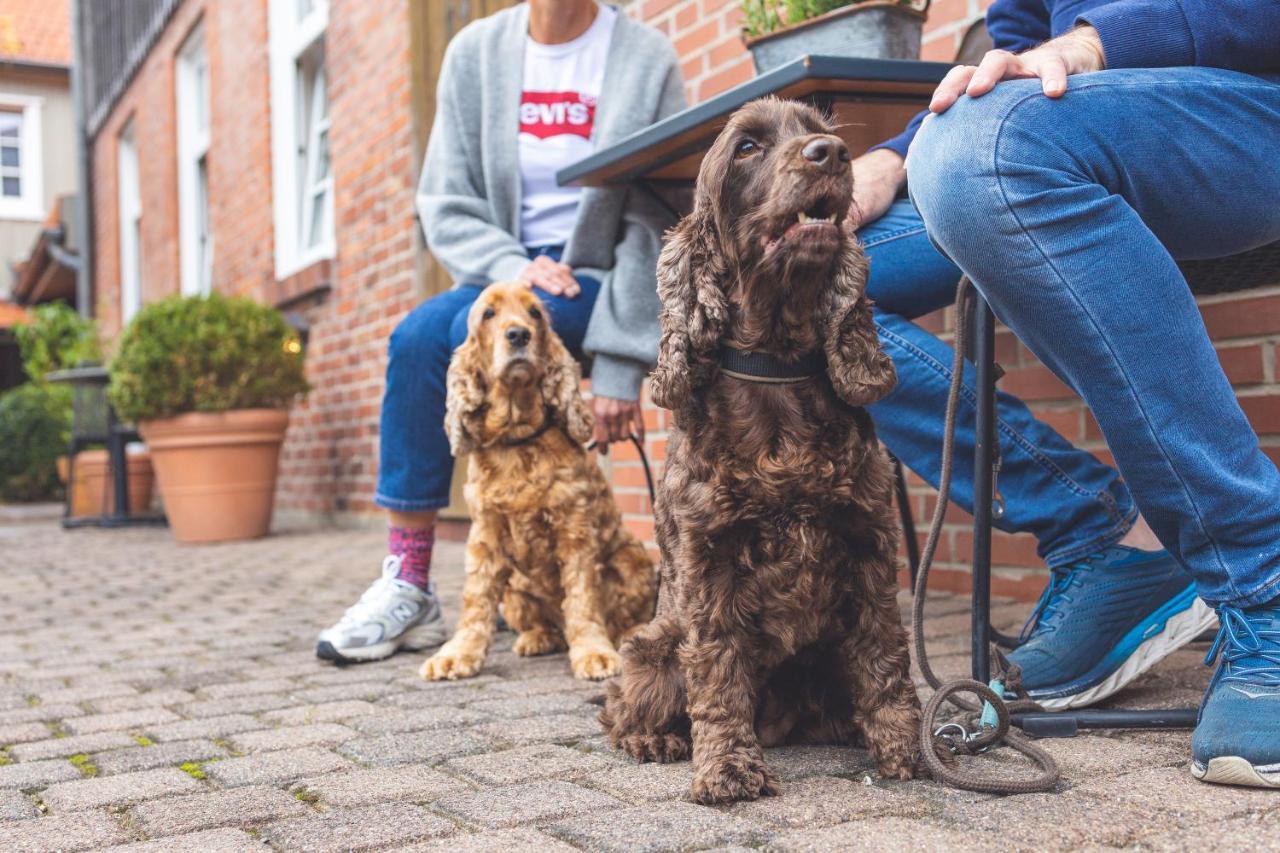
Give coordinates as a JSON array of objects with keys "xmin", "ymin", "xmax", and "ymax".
[{"xmin": 316, "ymin": 555, "xmax": 445, "ymax": 663}]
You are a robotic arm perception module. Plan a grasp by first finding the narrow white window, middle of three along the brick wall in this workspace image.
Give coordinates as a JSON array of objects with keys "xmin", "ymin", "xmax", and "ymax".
[{"xmin": 175, "ymin": 28, "xmax": 214, "ymax": 293}]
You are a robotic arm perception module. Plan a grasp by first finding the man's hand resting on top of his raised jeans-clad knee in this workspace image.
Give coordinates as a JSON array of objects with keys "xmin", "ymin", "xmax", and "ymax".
[{"xmin": 929, "ymin": 27, "xmax": 1106, "ymax": 113}]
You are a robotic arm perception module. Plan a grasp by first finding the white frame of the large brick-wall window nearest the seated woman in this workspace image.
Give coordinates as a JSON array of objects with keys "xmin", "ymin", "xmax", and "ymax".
[{"xmin": 268, "ymin": 0, "xmax": 337, "ymax": 279}]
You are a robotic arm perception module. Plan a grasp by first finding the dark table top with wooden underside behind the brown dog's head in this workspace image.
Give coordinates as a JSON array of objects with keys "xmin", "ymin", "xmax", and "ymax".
[{"xmin": 556, "ymin": 55, "xmax": 951, "ymax": 187}]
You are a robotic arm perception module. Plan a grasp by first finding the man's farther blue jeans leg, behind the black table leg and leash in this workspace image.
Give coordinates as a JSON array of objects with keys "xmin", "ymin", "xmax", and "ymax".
[{"xmin": 859, "ymin": 199, "xmax": 1137, "ymax": 566}]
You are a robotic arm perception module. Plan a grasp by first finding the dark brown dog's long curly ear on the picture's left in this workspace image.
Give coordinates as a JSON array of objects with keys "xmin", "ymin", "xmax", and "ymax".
[{"xmin": 650, "ymin": 212, "xmax": 728, "ymax": 409}]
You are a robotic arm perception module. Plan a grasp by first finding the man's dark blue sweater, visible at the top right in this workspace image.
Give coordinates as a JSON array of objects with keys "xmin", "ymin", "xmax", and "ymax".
[{"xmin": 873, "ymin": 0, "xmax": 1280, "ymax": 158}]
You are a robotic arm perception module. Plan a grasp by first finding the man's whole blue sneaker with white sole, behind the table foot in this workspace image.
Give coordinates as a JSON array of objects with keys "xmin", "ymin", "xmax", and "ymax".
[{"xmin": 1009, "ymin": 546, "xmax": 1215, "ymax": 711}]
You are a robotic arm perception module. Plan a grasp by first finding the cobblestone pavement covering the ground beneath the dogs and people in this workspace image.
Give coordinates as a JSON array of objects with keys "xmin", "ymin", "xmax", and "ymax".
[{"xmin": 0, "ymin": 523, "xmax": 1280, "ymax": 850}]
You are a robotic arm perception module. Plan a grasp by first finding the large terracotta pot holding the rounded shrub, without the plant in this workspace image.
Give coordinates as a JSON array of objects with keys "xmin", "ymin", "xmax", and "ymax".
[{"xmin": 138, "ymin": 409, "xmax": 289, "ymax": 542}]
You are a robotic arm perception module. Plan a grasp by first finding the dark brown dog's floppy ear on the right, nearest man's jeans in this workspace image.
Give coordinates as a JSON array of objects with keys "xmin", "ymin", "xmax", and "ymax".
[{"xmin": 824, "ymin": 240, "xmax": 897, "ymax": 406}]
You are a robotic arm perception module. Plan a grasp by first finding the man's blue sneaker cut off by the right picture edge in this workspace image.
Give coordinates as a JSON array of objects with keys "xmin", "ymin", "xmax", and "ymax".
[{"xmin": 1192, "ymin": 599, "xmax": 1280, "ymax": 788}]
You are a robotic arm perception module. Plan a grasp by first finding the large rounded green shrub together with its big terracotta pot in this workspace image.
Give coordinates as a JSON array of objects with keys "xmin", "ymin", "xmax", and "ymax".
[{"xmin": 108, "ymin": 295, "xmax": 307, "ymax": 542}]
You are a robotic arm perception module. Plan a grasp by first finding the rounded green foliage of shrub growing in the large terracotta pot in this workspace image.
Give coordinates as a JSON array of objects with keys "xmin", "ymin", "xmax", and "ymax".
[{"xmin": 108, "ymin": 293, "xmax": 307, "ymax": 421}]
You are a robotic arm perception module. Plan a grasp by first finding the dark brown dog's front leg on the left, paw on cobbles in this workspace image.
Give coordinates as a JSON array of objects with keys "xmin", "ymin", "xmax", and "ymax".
[{"xmin": 680, "ymin": 626, "xmax": 781, "ymax": 804}]
